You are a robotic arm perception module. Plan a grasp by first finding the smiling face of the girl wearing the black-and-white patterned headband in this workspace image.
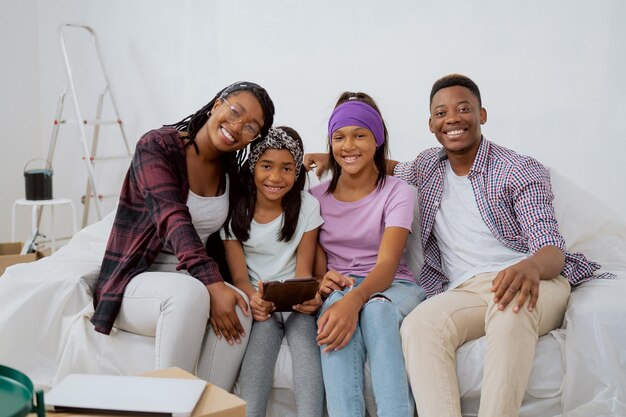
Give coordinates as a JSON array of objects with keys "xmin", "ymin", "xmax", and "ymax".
[{"xmin": 254, "ymin": 149, "xmax": 296, "ymax": 202}]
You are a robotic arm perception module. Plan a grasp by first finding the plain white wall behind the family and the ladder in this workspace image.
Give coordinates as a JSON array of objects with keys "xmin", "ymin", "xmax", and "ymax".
[{"xmin": 0, "ymin": 0, "xmax": 626, "ymax": 244}]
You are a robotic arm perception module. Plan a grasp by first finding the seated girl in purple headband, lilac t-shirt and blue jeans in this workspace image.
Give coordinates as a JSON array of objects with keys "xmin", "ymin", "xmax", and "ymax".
[{"xmin": 311, "ymin": 93, "xmax": 424, "ymax": 417}]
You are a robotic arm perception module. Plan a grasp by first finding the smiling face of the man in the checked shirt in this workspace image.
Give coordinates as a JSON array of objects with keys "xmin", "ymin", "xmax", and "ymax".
[{"xmin": 428, "ymin": 85, "xmax": 487, "ymax": 155}]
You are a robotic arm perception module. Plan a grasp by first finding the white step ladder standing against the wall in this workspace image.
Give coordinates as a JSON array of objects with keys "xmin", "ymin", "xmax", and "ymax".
[{"xmin": 50, "ymin": 23, "xmax": 132, "ymax": 227}]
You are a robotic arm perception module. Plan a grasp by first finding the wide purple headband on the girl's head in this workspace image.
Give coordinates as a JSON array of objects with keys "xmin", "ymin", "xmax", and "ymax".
[{"xmin": 328, "ymin": 101, "xmax": 385, "ymax": 148}]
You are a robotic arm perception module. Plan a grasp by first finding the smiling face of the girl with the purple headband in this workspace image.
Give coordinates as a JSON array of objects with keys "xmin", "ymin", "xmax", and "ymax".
[{"xmin": 331, "ymin": 126, "xmax": 376, "ymax": 175}]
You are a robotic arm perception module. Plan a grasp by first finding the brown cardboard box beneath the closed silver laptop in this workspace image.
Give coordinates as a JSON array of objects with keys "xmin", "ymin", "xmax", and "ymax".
[{"xmin": 44, "ymin": 368, "xmax": 246, "ymax": 417}]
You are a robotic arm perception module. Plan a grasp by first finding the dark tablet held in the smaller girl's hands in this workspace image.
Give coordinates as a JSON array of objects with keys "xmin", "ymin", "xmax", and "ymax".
[{"xmin": 263, "ymin": 278, "xmax": 319, "ymax": 311}]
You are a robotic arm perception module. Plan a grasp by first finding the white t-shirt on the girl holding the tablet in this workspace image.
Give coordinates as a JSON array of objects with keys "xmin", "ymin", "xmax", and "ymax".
[{"xmin": 220, "ymin": 191, "xmax": 324, "ymax": 287}]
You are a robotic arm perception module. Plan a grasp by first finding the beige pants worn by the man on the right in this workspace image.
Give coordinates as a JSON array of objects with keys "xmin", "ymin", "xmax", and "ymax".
[{"xmin": 400, "ymin": 273, "xmax": 571, "ymax": 417}]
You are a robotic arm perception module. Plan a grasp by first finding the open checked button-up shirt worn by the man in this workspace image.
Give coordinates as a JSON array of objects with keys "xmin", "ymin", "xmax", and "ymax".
[{"xmin": 394, "ymin": 138, "xmax": 610, "ymax": 297}]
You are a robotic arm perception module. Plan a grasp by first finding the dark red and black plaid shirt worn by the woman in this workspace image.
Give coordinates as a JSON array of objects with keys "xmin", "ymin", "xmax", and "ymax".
[{"xmin": 91, "ymin": 128, "xmax": 222, "ymax": 334}]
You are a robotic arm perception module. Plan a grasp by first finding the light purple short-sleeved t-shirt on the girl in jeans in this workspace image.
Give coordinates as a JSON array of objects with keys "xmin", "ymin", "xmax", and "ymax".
[{"xmin": 311, "ymin": 176, "xmax": 415, "ymax": 282}]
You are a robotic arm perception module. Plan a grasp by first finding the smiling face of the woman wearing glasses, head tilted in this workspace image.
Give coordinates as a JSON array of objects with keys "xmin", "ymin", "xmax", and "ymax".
[{"xmin": 205, "ymin": 91, "xmax": 264, "ymax": 152}]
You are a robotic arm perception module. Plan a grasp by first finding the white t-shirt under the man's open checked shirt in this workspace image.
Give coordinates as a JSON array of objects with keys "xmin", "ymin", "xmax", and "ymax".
[{"xmin": 433, "ymin": 161, "xmax": 528, "ymax": 289}]
